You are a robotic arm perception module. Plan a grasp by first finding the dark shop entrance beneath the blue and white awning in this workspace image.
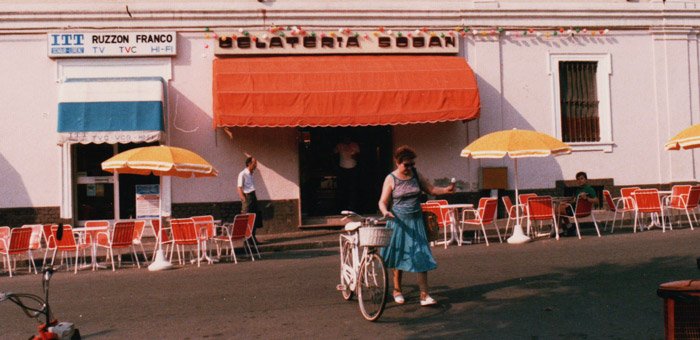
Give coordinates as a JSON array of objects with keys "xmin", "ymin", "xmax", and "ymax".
[{"xmin": 72, "ymin": 143, "xmax": 159, "ymax": 224}]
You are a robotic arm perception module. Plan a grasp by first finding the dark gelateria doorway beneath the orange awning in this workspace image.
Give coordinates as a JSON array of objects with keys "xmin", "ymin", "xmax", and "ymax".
[{"xmin": 299, "ymin": 126, "xmax": 392, "ymax": 217}]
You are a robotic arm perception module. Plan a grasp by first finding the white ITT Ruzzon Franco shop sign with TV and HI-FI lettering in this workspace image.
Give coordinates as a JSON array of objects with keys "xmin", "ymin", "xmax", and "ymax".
[{"xmin": 47, "ymin": 32, "xmax": 177, "ymax": 58}]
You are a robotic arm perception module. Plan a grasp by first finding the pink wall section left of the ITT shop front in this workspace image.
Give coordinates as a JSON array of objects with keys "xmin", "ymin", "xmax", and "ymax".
[{"xmin": 0, "ymin": 34, "xmax": 61, "ymax": 208}]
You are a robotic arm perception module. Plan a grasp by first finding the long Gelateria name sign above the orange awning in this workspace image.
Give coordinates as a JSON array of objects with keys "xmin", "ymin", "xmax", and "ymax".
[{"xmin": 214, "ymin": 31, "xmax": 459, "ymax": 55}]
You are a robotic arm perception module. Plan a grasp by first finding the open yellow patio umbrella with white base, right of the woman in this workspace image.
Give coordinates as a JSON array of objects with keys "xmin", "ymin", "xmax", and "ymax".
[{"xmin": 460, "ymin": 129, "xmax": 571, "ymax": 244}]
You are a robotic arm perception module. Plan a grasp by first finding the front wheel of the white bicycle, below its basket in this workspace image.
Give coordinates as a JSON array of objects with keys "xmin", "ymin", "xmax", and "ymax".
[{"xmin": 357, "ymin": 253, "xmax": 388, "ymax": 321}]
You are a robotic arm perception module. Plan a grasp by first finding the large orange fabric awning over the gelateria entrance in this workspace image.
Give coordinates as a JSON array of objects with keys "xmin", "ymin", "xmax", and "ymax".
[{"xmin": 213, "ymin": 56, "xmax": 480, "ymax": 127}]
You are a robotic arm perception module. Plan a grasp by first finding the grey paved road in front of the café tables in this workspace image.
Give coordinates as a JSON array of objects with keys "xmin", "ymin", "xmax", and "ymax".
[{"xmin": 0, "ymin": 229, "xmax": 700, "ymax": 339}]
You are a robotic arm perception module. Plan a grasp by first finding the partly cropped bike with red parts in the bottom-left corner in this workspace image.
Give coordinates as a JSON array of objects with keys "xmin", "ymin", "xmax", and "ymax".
[{"xmin": 0, "ymin": 267, "xmax": 80, "ymax": 340}]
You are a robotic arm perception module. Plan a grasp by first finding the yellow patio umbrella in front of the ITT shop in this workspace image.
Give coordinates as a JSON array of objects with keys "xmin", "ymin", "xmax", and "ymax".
[{"xmin": 102, "ymin": 145, "xmax": 218, "ymax": 271}]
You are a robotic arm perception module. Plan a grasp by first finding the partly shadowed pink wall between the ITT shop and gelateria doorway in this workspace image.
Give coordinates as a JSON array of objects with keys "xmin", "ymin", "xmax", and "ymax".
[{"xmin": 169, "ymin": 34, "xmax": 299, "ymax": 203}]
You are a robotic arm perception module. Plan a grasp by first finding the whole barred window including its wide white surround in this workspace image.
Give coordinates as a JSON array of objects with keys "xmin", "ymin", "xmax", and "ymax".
[{"xmin": 549, "ymin": 53, "xmax": 614, "ymax": 152}]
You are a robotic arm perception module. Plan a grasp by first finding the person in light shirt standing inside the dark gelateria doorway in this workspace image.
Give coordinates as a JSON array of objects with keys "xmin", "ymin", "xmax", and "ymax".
[{"xmin": 333, "ymin": 135, "xmax": 360, "ymax": 211}]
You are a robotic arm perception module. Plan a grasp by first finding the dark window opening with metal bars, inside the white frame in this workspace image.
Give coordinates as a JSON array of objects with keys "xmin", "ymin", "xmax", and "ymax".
[{"xmin": 559, "ymin": 61, "xmax": 600, "ymax": 143}]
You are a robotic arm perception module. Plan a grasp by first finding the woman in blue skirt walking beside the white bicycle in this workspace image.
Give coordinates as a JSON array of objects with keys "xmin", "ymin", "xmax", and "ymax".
[{"xmin": 379, "ymin": 146, "xmax": 455, "ymax": 306}]
